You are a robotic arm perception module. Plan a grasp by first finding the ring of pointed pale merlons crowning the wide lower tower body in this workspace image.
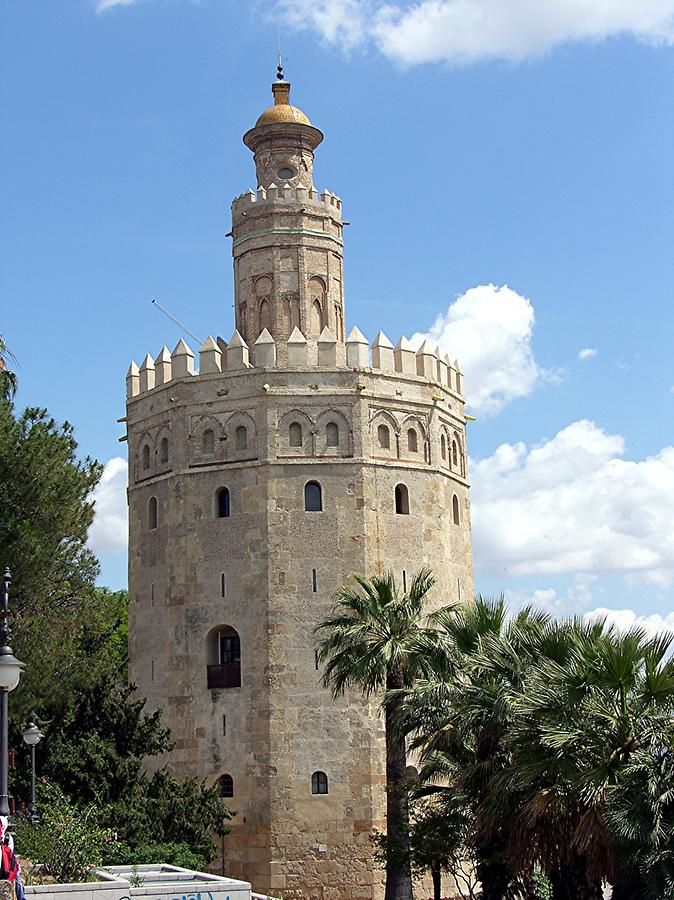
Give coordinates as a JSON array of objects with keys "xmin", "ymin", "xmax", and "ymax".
[{"xmin": 126, "ymin": 328, "xmax": 463, "ymax": 399}]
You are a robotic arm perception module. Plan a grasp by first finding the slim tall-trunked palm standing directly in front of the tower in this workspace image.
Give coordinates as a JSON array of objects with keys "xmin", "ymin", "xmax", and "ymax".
[{"xmin": 316, "ymin": 569, "xmax": 446, "ymax": 900}]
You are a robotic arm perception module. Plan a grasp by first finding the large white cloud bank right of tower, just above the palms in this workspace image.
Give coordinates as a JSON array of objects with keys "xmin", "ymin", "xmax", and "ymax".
[{"xmin": 470, "ymin": 420, "xmax": 674, "ymax": 586}]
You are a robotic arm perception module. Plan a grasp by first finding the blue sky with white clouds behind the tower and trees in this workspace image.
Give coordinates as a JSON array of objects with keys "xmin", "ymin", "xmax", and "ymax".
[{"xmin": 0, "ymin": 0, "xmax": 674, "ymax": 625}]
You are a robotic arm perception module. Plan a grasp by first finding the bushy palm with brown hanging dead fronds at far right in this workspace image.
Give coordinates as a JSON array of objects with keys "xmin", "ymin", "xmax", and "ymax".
[{"xmin": 496, "ymin": 622, "xmax": 674, "ymax": 900}]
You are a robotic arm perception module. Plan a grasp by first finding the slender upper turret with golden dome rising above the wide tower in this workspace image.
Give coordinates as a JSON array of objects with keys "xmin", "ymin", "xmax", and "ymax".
[{"xmin": 232, "ymin": 66, "xmax": 344, "ymax": 363}]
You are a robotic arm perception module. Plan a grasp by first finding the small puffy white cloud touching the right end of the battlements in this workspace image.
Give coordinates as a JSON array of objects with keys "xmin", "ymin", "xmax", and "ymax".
[{"xmin": 412, "ymin": 284, "xmax": 545, "ymax": 415}]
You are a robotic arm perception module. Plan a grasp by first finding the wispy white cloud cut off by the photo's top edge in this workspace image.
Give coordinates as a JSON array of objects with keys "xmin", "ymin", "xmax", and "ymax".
[{"xmin": 273, "ymin": 0, "xmax": 674, "ymax": 65}]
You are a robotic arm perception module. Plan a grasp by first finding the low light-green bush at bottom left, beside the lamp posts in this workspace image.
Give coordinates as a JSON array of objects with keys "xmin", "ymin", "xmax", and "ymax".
[{"xmin": 16, "ymin": 785, "xmax": 112, "ymax": 884}]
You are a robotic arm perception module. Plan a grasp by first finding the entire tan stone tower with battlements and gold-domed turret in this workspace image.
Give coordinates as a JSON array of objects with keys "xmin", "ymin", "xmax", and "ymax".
[{"xmin": 127, "ymin": 71, "xmax": 472, "ymax": 900}]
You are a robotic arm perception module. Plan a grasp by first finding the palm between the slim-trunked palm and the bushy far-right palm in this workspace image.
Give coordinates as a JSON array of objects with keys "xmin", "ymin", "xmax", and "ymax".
[{"xmin": 403, "ymin": 596, "xmax": 552, "ymax": 900}]
